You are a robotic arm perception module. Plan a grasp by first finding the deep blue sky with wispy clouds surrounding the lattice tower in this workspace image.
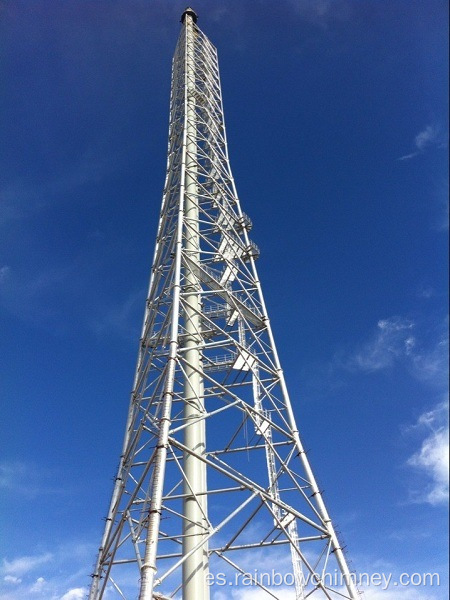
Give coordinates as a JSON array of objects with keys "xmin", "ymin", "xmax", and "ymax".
[{"xmin": 0, "ymin": 0, "xmax": 448, "ymax": 600}]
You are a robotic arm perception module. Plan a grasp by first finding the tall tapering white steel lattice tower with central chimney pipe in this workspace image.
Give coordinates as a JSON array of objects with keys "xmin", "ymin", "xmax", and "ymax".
[{"xmin": 90, "ymin": 8, "xmax": 359, "ymax": 600}]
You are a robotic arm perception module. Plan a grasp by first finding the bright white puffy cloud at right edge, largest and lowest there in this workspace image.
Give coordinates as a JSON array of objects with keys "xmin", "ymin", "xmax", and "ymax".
[{"xmin": 407, "ymin": 402, "xmax": 449, "ymax": 505}]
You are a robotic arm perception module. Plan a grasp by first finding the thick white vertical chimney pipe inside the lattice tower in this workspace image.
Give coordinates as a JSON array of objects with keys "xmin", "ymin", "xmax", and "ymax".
[{"xmin": 183, "ymin": 10, "xmax": 210, "ymax": 600}]
